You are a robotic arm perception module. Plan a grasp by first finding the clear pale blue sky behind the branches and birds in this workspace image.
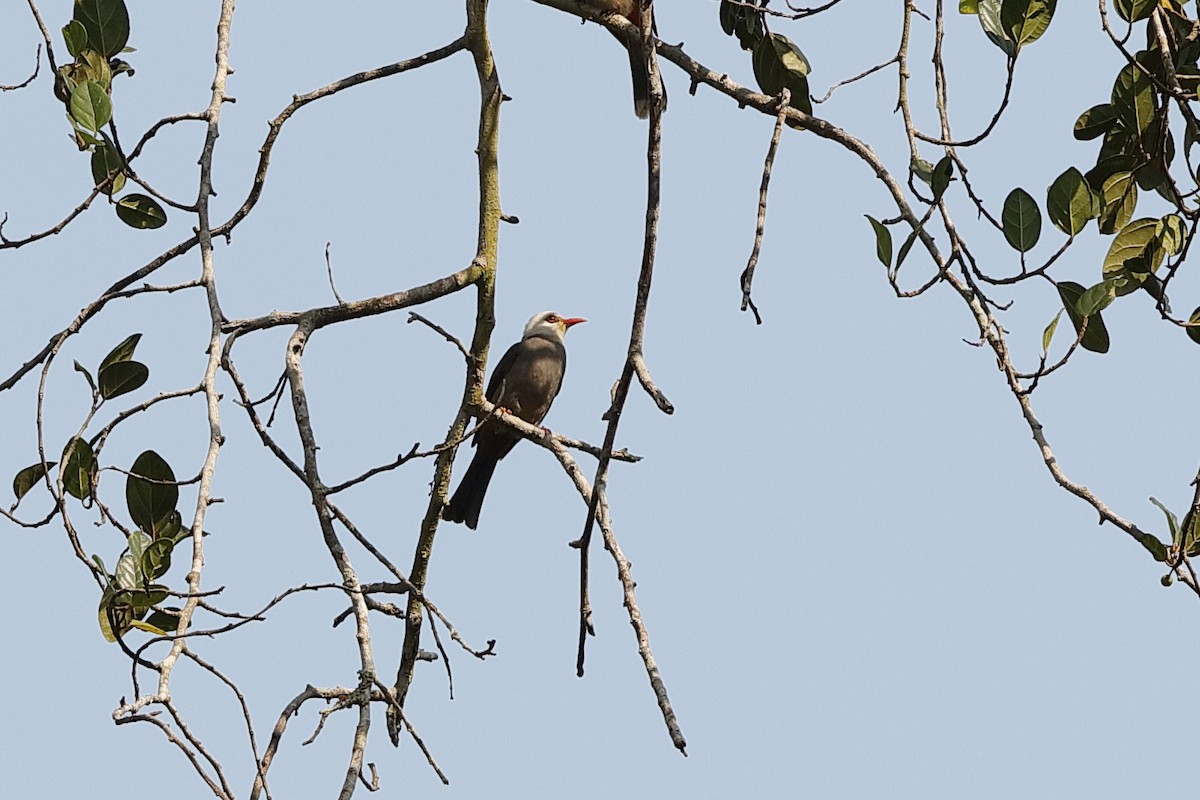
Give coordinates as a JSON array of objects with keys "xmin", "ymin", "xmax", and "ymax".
[{"xmin": 0, "ymin": 0, "xmax": 1200, "ymax": 798}]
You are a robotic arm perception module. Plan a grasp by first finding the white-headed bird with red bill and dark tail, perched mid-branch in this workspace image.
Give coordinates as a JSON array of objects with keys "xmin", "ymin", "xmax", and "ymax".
[{"xmin": 442, "ymin": 311, "xmax": 588, "ymax": 530}]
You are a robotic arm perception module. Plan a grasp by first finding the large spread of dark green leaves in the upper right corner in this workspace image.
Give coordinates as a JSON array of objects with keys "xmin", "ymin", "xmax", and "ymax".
[{"xmin": 892, "ymin": 0, "xmax": 1200, "ymax": 353}]
